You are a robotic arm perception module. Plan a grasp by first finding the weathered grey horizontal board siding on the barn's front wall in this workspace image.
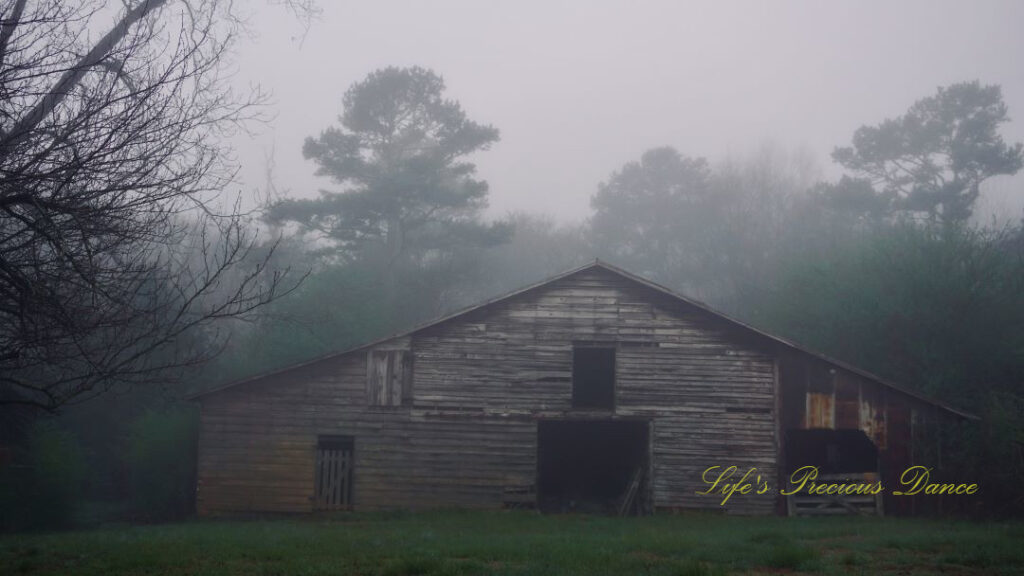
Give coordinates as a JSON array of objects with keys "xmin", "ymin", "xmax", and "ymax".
[{"xmin": 199, "ymin": 269, "xmax": 777, "ymax": 513}]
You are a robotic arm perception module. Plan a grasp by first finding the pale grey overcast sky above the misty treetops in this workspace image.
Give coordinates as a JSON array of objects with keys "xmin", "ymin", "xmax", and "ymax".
[{"xmin": 228, "ymin": 0, "xmax": 1024, "ymax": 220}]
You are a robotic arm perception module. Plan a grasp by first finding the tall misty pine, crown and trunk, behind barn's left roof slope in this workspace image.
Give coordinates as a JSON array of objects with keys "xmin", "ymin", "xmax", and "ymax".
[{"xmin": 256, "ymin": 67, "xmax": 511, "ymax": 338}]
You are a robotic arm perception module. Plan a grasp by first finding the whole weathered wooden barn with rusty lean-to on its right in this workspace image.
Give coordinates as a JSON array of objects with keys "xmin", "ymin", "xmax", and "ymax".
[{"xmin": 196, "ymin": 261, "xmax": 970, "ymax": 515}]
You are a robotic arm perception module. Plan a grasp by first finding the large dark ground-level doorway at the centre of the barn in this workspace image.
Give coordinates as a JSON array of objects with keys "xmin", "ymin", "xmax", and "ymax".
[{"xmin": 537, "ymin": 420, "xmax": 650, "ymax": 513}]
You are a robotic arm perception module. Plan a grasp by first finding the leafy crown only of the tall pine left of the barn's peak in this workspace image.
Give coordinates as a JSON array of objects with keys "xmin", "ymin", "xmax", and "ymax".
[{"xmin": 265, "ymin": 67, "xmax": 508, "ymax": 265}]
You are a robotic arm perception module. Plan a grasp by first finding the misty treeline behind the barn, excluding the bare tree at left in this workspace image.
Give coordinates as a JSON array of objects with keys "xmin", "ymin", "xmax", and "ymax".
[{"xmin": 2, "ymin": 68, "xmax": 1024, "ymax": 521}]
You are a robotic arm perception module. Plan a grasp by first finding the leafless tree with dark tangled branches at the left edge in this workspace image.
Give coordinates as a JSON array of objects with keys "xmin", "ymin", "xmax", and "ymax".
[{"xmin": 0, "ymin": 0, "xmax": 311, "ymax": 411}]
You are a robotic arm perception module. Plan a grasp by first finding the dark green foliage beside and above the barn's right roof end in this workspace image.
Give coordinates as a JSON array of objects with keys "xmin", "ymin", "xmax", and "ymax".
[{"xmin": 761, "ymin": 221, "xmax": 1024, "ymax": 515}]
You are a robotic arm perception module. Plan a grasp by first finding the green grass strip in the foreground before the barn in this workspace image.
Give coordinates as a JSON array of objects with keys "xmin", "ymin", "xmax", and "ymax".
[{"xmin": 0, "ymin": 511, "xmax": 1024, "ymax": 576}]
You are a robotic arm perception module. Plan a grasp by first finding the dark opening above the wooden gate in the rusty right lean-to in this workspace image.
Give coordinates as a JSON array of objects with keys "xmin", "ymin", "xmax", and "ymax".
[{"xmin": 785, "ymin": 428, "xmax": 879, "ymax": 475}]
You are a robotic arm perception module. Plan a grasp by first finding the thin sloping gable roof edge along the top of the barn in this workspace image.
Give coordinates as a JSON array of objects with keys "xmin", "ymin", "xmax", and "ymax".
[{"xmin": 187, "ymin": 259, "xmax": 978, "ymax": 420}]
